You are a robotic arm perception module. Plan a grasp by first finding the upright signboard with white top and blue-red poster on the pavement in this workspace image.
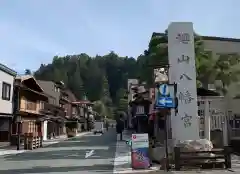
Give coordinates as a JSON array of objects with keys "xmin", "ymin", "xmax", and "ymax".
[{"xmin": 131, "ymin": 134, "xmax": 150, "ymax": 169}]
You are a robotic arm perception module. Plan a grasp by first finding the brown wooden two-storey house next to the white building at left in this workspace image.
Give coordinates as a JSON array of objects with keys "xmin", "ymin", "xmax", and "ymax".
[{"xmin": 11, "ymin": 75, "xmax": 48, "ymax": 142}]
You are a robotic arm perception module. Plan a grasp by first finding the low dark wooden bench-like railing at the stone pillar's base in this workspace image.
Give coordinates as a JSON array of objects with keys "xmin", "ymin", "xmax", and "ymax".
[{"xmin": 174, "ymin": 146, "xmax": 231, "ymax": 171}]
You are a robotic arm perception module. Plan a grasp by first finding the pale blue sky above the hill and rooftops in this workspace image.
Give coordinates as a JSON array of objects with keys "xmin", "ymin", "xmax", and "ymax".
[{"xmin": 0, "ymin": 0, "xmax": 240, "ymax": 71}]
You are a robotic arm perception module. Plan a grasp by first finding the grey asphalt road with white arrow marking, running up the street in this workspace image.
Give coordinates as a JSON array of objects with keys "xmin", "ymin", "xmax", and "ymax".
[{"xmin": 0, "ymin": 129, "xmax": 116, "ymax": 174}]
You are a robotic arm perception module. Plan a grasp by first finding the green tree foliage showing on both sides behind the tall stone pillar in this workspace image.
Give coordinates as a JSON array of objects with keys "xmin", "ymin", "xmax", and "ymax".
[{"xmin": 144, "ymin": 31, "xmax": 239, "ymax": 94}]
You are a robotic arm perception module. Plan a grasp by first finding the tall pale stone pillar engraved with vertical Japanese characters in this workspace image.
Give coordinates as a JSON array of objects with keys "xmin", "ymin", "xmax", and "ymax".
[{"xmin": 168, "ymin": 22, "xmax": 199, "ymax": 142}]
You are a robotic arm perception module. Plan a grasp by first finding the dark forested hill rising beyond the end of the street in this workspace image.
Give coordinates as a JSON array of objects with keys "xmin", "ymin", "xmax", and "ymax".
[{"xmin": 34, "ymin": 52, "xmax": 141, "ymax": 118}]
